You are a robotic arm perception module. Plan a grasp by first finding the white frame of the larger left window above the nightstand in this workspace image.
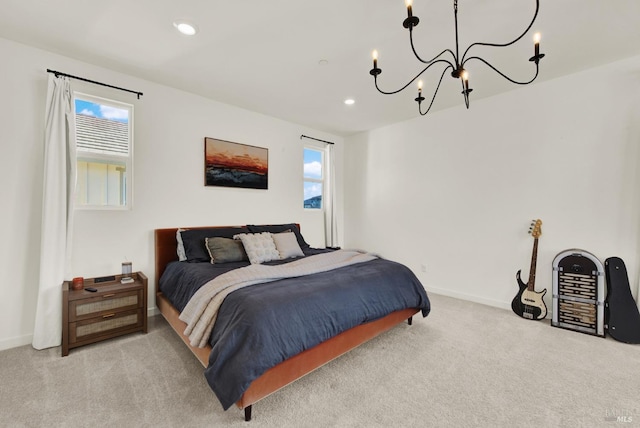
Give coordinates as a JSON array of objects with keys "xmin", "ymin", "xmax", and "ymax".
[{"xmin": 73, "ymin": 91, "xmax": 134, "ymax": 211}]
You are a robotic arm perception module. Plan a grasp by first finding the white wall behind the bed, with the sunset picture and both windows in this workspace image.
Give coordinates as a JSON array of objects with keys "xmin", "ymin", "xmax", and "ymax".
[{"xmin": 0, "ymin": 39, "xmax": 342, "ymax": 349}]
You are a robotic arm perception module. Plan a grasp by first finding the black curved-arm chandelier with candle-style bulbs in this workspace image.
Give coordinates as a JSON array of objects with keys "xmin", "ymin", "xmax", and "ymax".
[{"xmin": 369, "ymin": 0, "xmax": 544, "ymax": 116}]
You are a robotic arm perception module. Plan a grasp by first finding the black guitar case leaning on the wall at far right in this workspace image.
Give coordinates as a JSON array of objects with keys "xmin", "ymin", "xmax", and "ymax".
[{"xmin": 604, "ymin": 257, "xmax": 640, "ymax": 343}]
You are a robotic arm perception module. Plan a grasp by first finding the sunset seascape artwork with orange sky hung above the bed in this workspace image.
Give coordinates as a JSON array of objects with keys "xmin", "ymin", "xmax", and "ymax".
[{"xmin": 204, "ymin": 137, "xmax": 269, "ymax": 189}]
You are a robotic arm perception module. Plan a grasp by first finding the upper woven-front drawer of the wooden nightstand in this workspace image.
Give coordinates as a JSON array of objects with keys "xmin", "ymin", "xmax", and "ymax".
[{"xmin": 69, "ymin": 290, "xmax": 143, "ymax": 322}]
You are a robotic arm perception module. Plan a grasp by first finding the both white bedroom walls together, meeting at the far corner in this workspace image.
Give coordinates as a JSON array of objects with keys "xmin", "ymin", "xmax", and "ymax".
[{"xmin": 0, "ymin": 31, "xmax": 640, "ymax": 349}]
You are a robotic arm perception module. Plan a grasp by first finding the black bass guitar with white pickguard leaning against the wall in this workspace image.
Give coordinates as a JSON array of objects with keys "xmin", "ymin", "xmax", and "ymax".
[{"xmin": 511, "ymin": 219, "xmax": 547, "ymax": 320}]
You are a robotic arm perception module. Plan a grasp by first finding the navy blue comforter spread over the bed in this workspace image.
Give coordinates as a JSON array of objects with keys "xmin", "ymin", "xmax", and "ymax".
[{"xmin": 160, "ymin": 252, "xmax": 430, "ymax": 410}]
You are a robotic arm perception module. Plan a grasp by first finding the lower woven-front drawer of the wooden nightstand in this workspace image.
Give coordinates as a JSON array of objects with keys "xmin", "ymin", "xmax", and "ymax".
[{"xmin": 69, "ymin": 309, "xmax": 143, "ymax": 345}]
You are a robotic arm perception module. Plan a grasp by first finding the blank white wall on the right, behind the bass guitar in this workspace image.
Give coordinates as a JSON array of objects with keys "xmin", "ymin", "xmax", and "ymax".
[{"xmin": 345, "ymin": 57, "xmax": 640, "ymax": 308}]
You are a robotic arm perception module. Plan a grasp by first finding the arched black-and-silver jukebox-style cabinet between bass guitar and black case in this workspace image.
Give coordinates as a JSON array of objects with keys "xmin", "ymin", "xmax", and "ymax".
[{"xmin": 551, "ymin": 249, "xmax": 605, "ymax": 337}]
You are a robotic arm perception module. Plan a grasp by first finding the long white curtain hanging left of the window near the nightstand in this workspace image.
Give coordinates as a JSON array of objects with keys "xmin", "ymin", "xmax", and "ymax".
[{"xmin": 33, "ymin": 74, "xmax": 76, "ymax": 349}]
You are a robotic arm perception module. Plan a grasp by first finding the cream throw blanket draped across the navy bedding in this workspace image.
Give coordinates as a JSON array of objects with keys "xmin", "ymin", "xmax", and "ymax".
[{"xmin": 180, "ymin": 250, "xmax": 377, "ymax": 348}]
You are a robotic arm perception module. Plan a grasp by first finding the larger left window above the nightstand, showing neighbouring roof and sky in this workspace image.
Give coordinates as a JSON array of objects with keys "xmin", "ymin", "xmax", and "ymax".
[{"xmin": 75, "ymin": 93, "xmax": 133, "ymax": 209}]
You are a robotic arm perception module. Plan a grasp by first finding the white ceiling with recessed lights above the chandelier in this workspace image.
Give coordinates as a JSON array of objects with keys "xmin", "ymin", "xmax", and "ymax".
[{"xmin": 0, "ymin": 0, "xmax": 640, "ymax": 135}]
